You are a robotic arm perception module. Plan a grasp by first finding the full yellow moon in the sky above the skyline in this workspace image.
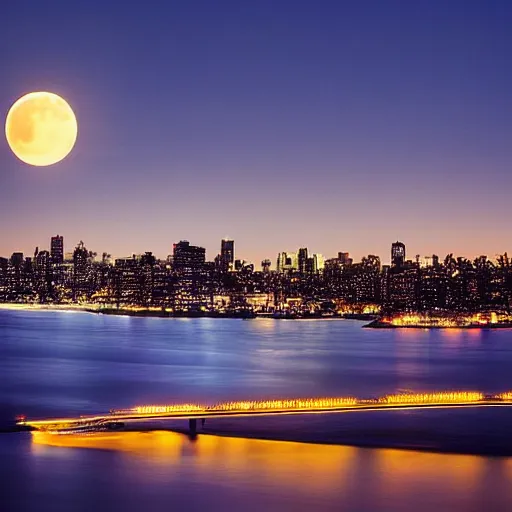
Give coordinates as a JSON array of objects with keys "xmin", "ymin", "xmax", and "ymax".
[{"xmin": 5, "ymin": 92, "xmax": 78, "ymax": 166}]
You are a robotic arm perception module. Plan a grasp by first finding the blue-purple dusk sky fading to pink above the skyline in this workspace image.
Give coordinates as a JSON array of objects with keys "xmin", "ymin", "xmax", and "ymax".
[{"xmin": 0, "ymin": 0, "xmax": 512, "ymax": 266}]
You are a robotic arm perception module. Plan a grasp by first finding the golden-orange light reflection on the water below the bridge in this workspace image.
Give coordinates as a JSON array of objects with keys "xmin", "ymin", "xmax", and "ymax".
[{"xmin": 26, "ymin": 431, "xmax": 512, "ymax": 511}]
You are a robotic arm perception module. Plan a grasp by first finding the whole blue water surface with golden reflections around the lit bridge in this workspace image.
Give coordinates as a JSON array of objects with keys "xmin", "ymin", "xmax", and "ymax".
[{"xmin": 0, "ymin": 311, "xmax": 512, "ymax": 512}]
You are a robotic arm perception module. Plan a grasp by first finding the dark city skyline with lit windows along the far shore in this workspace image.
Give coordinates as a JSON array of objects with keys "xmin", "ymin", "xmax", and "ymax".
[{"xmin": 0, "ymin": 235, "xmax": 512, "ymax": 329}]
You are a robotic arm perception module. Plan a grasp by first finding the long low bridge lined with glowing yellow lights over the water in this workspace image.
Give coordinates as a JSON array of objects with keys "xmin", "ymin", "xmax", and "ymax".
[{"xmin": 17, "ymin": 391, "xmax": 512, "ymax": 435}]
